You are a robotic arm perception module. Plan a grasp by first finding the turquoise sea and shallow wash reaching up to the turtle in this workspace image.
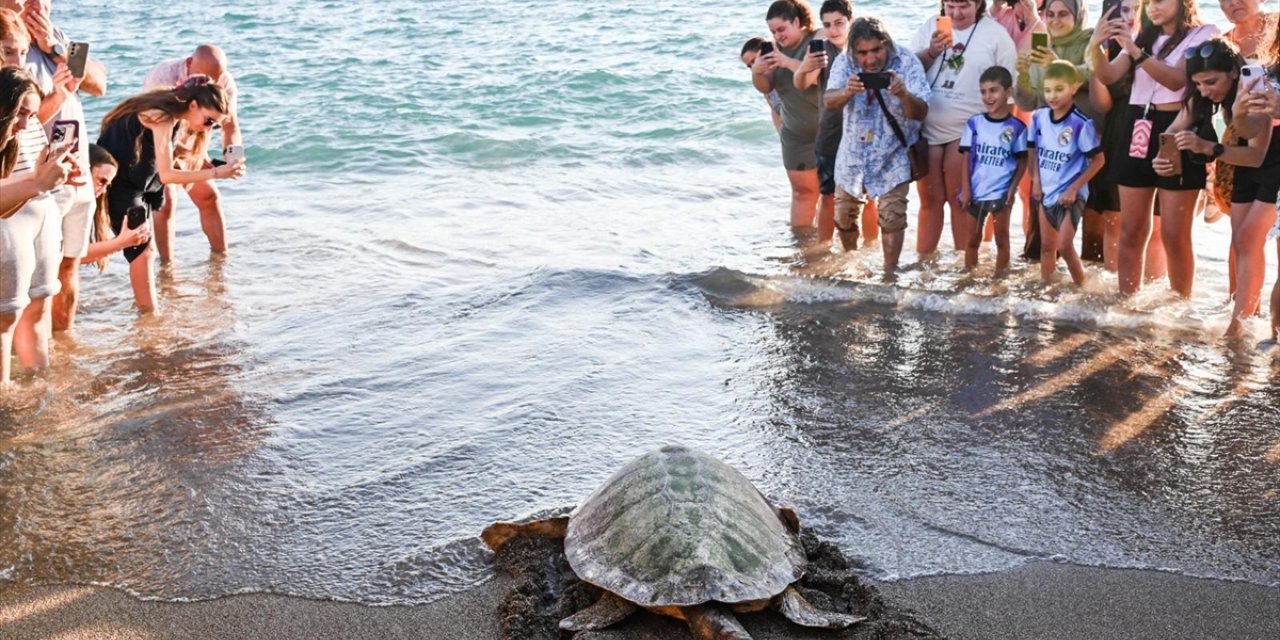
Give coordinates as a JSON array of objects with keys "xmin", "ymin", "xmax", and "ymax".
[{"xmin": 0, "ymin": 0, "xmax": 1280, "ymax": 604}]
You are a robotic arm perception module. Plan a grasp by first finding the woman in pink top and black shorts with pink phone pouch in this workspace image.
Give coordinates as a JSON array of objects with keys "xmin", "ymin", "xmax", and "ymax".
[{"xmin": 1094, "ymin": 0, "xmax": 1219, "ymax": 297}]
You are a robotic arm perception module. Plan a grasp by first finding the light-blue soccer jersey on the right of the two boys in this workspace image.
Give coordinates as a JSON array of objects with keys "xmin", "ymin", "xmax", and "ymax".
[{"xmin": 1028, "ymin": 106, "xmax": 1102, "ymax": 206}]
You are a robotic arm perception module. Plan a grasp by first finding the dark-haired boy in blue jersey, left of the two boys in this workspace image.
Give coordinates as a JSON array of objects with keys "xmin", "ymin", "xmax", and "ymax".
[{"xmin": 960, "ymin": 65, "xmax": 1027, "ymax": 274}]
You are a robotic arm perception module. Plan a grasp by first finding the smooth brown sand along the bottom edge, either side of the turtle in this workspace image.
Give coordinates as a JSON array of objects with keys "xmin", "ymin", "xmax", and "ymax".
[{"xmin": 0, "ymin": 563, "xmax": 1280, "ymax": 640}]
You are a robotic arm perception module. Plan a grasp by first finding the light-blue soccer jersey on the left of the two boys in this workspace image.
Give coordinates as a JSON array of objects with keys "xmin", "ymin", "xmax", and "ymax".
[{"xmin": 960, "ymin": 114, "xmax": 1027, "ymax": 202}]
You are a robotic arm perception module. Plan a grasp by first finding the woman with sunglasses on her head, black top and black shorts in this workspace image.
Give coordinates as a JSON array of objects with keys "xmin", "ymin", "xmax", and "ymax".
[{"xmin": 1155, "ymin": 38, "xmax": 1280, "ymax": 338}]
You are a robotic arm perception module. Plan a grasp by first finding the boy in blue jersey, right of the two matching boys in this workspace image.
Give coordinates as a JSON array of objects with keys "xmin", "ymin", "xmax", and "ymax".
[{"xmin": 1028, "ymin": 60, "xmax": 1106, "ymax": 285}]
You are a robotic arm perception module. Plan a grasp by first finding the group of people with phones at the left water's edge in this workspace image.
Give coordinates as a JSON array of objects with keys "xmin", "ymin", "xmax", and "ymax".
[{"xmin": 0, "ymin": 0, "xmax": 244, "ymax": 385}]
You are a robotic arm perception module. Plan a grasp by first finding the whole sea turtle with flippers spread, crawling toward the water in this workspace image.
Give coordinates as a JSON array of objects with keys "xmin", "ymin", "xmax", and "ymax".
[{"xmin": 481, "ymin": 445, "xmax": 865, "ymax": 640}]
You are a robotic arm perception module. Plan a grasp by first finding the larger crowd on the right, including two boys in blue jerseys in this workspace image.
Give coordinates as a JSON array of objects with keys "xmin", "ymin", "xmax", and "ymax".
[{"xmin": 741, "ymin": 0, "xmax": 1280, "ymax": 338}]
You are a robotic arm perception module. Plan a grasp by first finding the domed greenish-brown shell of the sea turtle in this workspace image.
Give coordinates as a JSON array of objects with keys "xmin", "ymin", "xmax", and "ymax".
[{"xmin": 564, "ymin": 447, "xmax": 805, "ymax": 607}]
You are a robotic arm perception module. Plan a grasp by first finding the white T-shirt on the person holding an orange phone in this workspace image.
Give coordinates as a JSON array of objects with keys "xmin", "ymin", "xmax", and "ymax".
[{"xmin": 910, "ymin": 17, "xmax": 1018, "ymax": 145}]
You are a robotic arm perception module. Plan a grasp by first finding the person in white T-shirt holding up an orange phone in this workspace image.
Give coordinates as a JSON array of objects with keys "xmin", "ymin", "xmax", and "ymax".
[{"xmin": 911, "ymin": 0, "xmax": 1018, "ymax": 257}]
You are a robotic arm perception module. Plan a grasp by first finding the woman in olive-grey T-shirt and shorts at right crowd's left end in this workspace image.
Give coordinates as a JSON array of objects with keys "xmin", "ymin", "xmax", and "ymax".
[{"xmin": 751, "ymin": 0, "xmax": 822, "ymax": 228}]
